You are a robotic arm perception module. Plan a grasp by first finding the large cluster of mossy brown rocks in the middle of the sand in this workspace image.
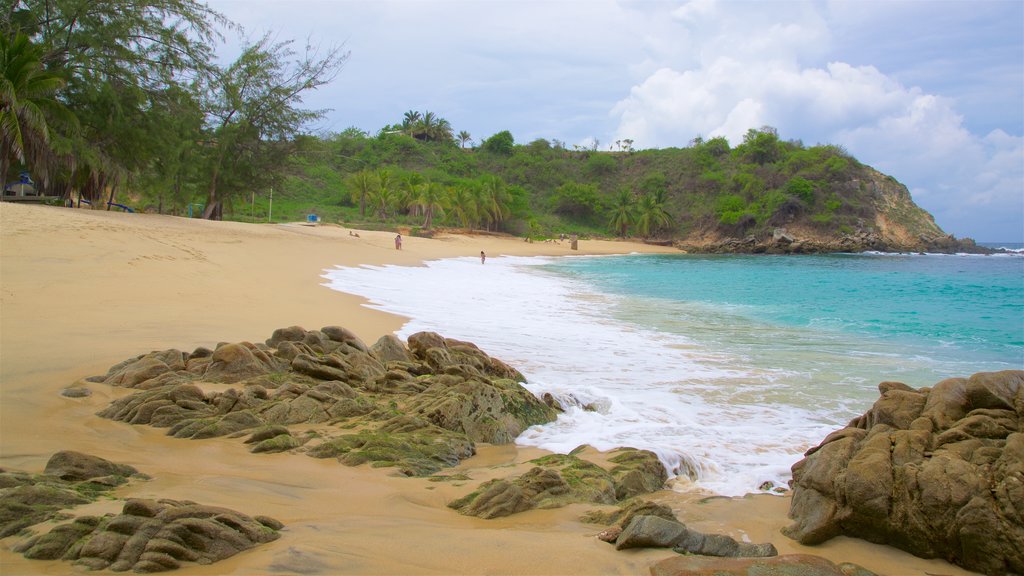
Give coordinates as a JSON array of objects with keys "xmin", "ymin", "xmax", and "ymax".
[{"xmin": 91, "ymin": 326, "xmax": 556, "ymax": 476}]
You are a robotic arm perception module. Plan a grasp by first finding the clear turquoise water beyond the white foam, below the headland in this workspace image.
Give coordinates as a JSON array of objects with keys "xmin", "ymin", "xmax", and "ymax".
[{"xmin": 548, "ymin": 254, "xmax": 1024, "ymax": 377}]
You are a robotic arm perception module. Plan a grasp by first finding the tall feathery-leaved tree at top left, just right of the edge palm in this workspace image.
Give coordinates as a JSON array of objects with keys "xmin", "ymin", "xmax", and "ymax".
[{"xmin": 14, "ymin": 0, "xmax": 226, "ymax": 199}]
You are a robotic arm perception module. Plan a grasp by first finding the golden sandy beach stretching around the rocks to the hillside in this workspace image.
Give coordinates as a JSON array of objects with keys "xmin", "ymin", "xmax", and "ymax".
[{"xmin": 0, "ymin": 203, "xmax": 969, "ymax": 575}]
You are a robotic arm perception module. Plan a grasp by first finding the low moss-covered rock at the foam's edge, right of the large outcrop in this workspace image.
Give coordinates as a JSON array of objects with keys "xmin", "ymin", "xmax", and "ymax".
[{"xmin": 449, "ymin": 448, "xmax": 668, "ymax": 519}]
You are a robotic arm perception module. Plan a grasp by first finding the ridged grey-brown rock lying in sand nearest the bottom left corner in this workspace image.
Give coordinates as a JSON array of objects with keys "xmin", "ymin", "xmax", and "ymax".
[{"xmin": 15, "ymin": 499, "xmax": 283, "ymax": 573}]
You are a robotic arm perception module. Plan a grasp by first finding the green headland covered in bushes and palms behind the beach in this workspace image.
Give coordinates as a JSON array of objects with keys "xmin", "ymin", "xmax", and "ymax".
[{"xmin": 190, "ymin": 123, "xmax": 965, "ymax": 252}]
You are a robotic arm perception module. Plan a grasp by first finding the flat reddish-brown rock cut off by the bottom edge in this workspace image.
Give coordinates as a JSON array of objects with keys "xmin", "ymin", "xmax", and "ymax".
[{"xmin": 650, "ymin": 554, "xmax": 876, "ymax": 576}]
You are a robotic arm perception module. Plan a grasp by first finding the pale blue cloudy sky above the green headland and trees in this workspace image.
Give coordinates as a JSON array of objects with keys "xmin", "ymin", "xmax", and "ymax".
[{"xmin": 208, "ymin": 0, "xmax": 1024, "ymax": 242}]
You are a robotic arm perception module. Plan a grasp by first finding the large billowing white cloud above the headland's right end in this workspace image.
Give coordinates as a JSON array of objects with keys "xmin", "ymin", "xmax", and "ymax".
[{"xmin": 611, "ymin": 1, "xmax": 1024, "ymax": 240}]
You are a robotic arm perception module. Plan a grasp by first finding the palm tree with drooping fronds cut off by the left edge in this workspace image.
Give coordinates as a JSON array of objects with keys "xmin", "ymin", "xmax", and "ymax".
[{"xmin": 0, "ymin": 33, "xmax": 76, "ymax": 187}]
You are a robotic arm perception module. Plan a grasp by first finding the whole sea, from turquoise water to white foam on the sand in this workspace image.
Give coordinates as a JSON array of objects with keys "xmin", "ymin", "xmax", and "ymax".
[{"xmin": 324, "ymin": 247, "xmax": 1024, "ymax": 496}]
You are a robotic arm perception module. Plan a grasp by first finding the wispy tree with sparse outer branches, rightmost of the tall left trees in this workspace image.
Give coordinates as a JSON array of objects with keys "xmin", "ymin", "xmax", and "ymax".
[{"xmin": 197, "ymin": 36, "xmax": 348, "ymax": 219}]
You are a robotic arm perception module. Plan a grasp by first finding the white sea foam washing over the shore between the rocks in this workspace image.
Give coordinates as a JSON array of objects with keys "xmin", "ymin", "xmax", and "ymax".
[{"xmin": 324, "ymin": 257, "xmax": 843, "ymax": 496}]
